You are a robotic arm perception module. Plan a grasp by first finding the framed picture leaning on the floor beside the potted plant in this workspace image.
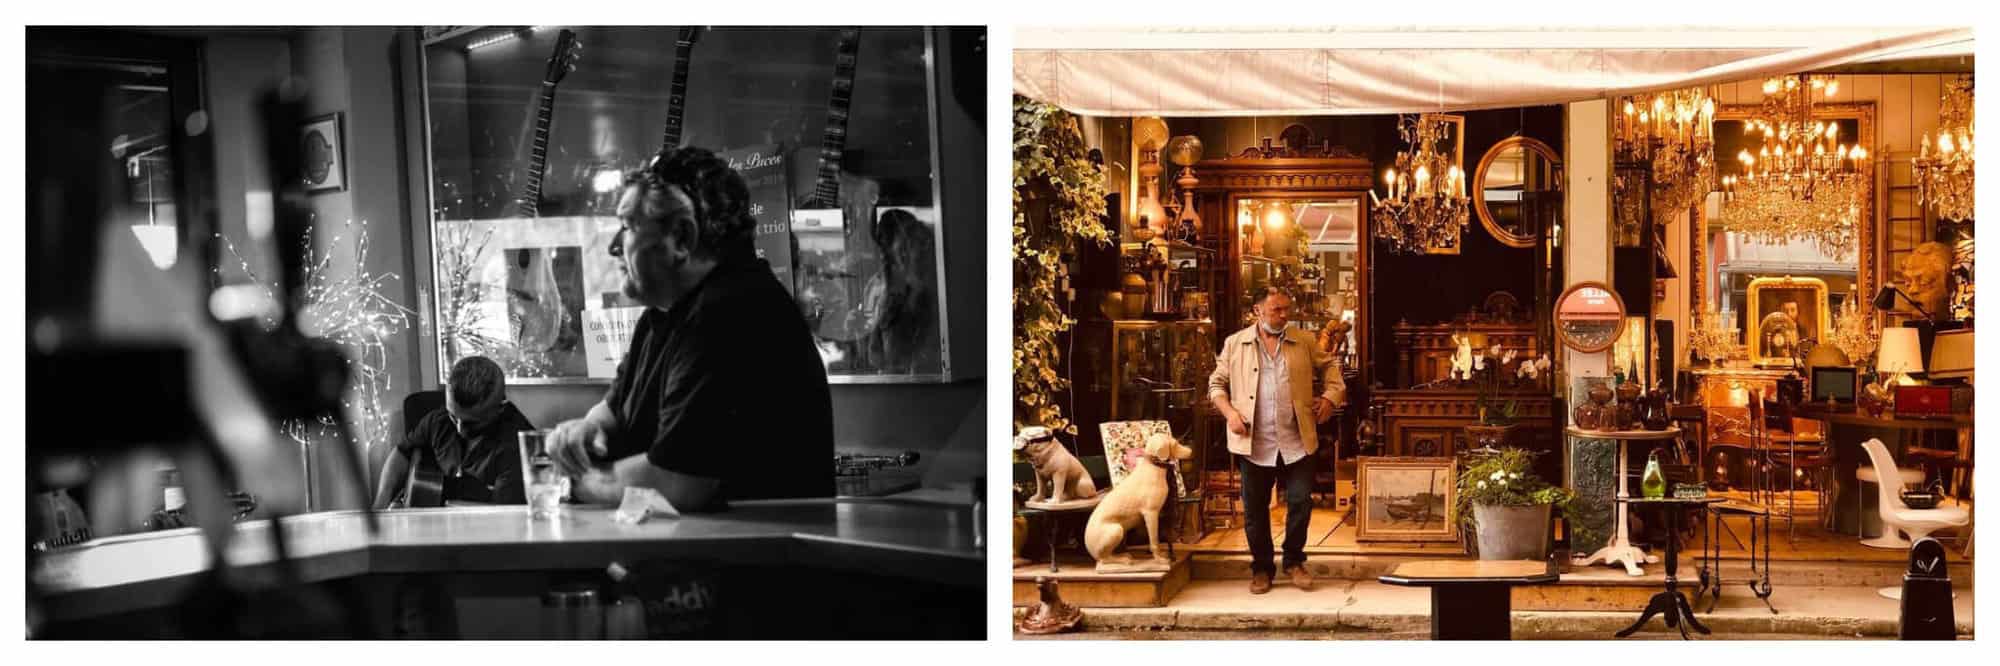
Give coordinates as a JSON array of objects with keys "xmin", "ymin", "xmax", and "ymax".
[{"xmin": 1354, "ymin": 456, "xmax": 1458, "ymax": 542}]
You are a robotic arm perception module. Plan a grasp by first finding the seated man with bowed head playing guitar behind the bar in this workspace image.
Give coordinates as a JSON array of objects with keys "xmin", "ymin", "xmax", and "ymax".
[{"xmin": 374, "ymin": 356, "xmax": 534, "ymax": 510}]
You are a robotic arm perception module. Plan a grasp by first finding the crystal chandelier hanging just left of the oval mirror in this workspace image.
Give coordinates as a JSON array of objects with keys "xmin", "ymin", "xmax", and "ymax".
[{"xmin": 1368, "ymin": 114, "xmax": 1470, "ymax": 254}]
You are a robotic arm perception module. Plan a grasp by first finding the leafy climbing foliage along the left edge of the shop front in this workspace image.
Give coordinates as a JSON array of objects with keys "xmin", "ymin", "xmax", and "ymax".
[{"xmin": 1014, "ymin": 96, "xmax": 1112, "ymax": 434}]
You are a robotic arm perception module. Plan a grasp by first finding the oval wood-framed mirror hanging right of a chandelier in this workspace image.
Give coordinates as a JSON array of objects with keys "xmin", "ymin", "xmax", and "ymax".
[{"xmin": 1472, "ymin": 136, "xmax": 1562, "ymax": 248}]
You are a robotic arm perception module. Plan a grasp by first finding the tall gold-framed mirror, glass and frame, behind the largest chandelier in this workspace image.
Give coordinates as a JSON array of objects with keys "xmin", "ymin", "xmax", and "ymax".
[{"xmin": 1688, "ymin": 102, "xmax": 1880, "ymax": 362}]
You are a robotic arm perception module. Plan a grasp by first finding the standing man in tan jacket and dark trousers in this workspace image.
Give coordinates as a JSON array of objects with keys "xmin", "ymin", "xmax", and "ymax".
[{"xmin": 1208, "ymin": 288, "xmax": 1348, "ymax": 594}]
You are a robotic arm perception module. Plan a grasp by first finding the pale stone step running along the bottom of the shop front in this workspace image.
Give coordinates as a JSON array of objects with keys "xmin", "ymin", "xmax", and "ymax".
[{"xmin": 1014, "ymin": 580, "xmax": 1974, "ymax": 640}]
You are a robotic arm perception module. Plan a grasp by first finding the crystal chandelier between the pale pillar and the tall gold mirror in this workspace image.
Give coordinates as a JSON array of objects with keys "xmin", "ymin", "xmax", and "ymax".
[{"xmin": 1612, "ymin": 86, "xmax": 1716, "ymax": 212}]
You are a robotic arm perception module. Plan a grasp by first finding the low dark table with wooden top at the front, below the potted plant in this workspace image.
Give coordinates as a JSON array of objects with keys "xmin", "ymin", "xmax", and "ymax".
[{"xmin": 1378, "ymin": 560, "xmax": 1558, "ymax": 640}]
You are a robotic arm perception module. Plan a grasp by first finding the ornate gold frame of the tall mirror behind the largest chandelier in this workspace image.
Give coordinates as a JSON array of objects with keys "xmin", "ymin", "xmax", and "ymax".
[{"xmin": 1688, "ymin": 102, "xmax": 1884, "ymax": 326}]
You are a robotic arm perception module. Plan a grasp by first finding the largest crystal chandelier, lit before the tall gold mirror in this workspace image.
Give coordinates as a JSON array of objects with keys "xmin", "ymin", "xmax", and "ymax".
[{"xmin": 1722, "ymin": 74, "xmax": 1870, "ymax": 258}]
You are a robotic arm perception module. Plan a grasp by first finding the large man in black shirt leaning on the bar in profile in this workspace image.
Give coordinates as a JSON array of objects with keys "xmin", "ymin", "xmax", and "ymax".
[{"xmin": 550, "ymin": 148, "xmax": 834, "ymax": 510}]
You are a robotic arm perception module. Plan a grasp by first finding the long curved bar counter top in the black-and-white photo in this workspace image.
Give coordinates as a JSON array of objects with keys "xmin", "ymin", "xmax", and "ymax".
[{"xmin": 30, "ymin": 494, "xmax": 984, "ymax": 620}]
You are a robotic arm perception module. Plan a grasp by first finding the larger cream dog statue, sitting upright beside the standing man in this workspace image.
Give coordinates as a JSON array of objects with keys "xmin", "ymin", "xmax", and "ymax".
[{"xmin": 1084, "ymin": 432, "xmax": 1194, "ymax": 574}]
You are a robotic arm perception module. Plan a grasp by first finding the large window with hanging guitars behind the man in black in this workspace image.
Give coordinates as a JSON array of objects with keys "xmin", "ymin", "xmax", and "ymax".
[{"xmin": 424, "ymin": 26, "xmax": 946, "ymax": 382}]
